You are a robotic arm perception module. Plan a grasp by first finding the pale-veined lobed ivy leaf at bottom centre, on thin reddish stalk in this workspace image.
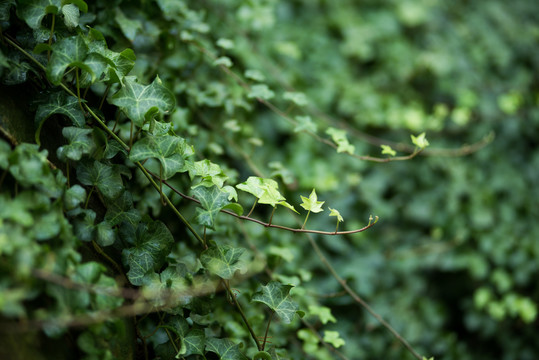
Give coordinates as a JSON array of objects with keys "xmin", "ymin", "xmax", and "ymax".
[{"xmin": 251, "ymin": 281, "xmax": 304, "ymax": 324}]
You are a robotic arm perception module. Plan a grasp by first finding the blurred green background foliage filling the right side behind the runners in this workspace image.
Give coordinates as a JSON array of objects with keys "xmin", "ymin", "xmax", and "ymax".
[{"xmin": 4, "ymin": 0, "xmax": 539, "ymax": 360}]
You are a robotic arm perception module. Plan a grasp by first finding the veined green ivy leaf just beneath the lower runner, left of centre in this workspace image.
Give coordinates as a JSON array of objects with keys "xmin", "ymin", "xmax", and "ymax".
[{"xmin": 200, "ymin": 245, "xmax": 245, "ymax": 279}]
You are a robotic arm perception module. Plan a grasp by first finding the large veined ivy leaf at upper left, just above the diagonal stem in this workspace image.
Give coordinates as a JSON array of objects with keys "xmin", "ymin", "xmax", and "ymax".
[{"xmin": 47, "ymin": 35, "xmax": 95, "ymax": 85}]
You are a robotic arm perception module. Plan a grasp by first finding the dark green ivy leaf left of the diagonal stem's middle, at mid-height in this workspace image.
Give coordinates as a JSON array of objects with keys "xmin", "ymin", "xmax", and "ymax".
[{"xmin": 77, "ymin": 161, "xmax": 124, "ymax": 199}]
